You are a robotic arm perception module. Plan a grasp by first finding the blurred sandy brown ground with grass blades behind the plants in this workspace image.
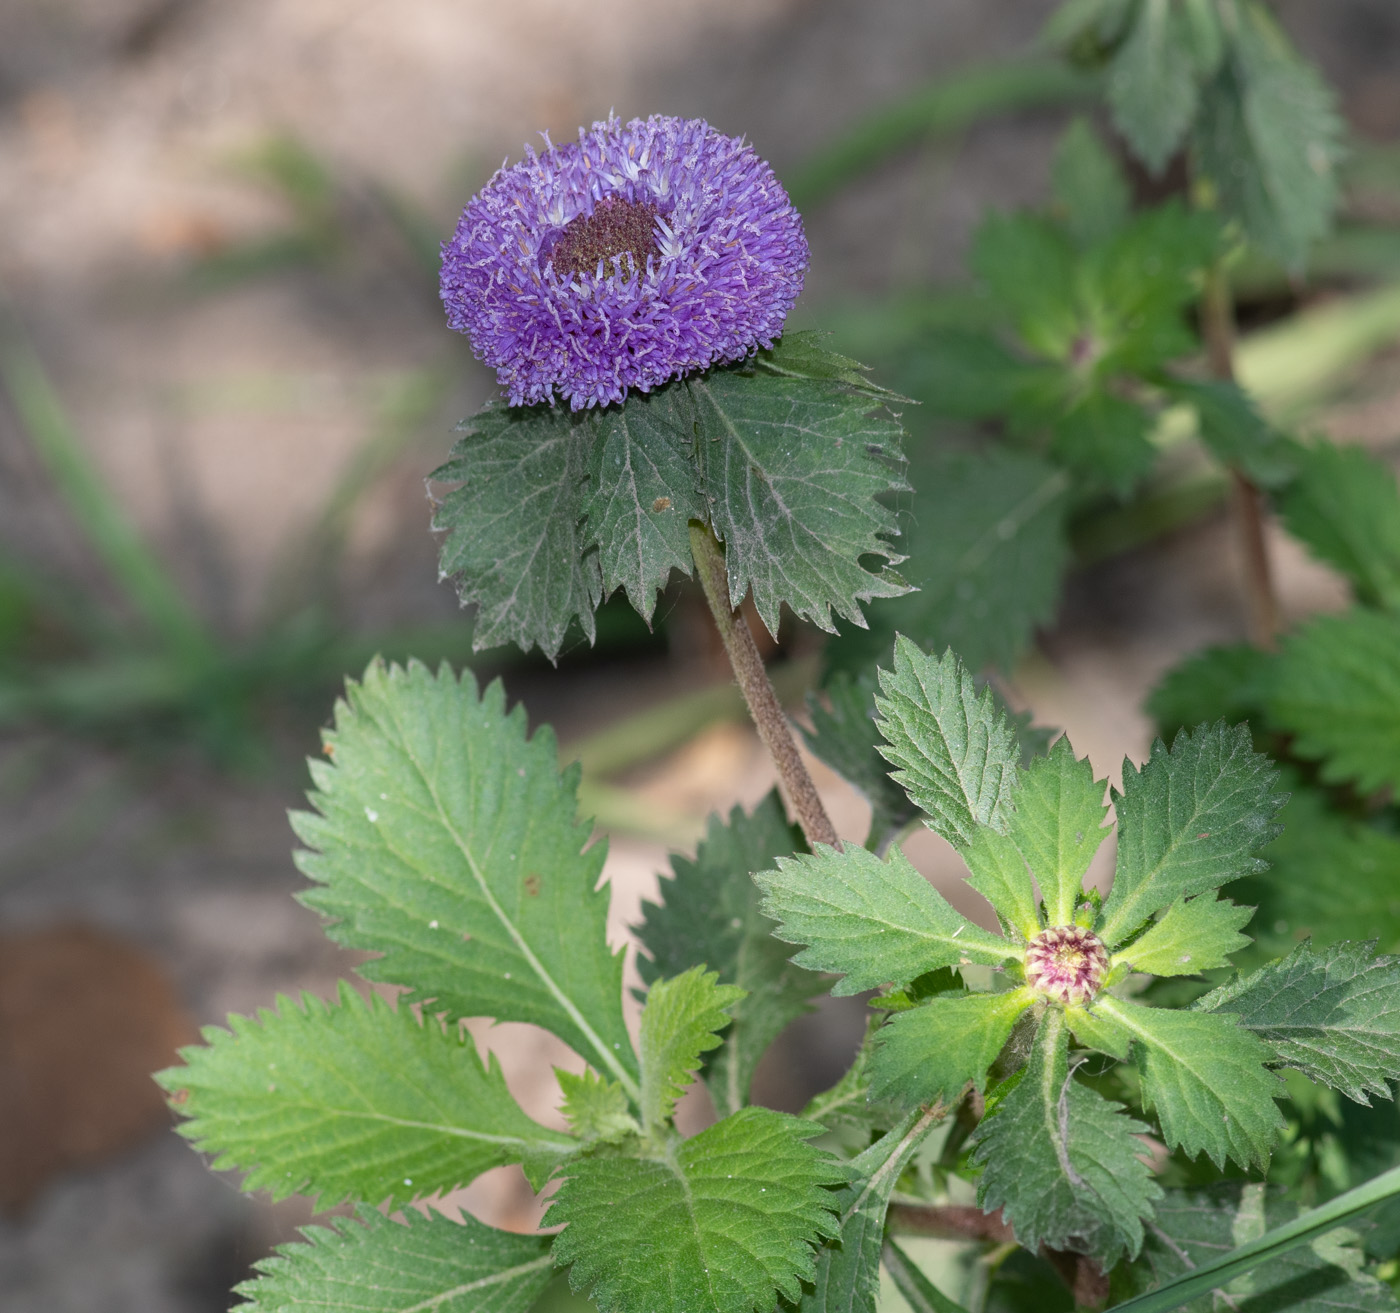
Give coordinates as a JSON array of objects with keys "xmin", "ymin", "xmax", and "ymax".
[{"xmin": 0, "ymin": 0, "xmax": 1400, "ymax": 1313}]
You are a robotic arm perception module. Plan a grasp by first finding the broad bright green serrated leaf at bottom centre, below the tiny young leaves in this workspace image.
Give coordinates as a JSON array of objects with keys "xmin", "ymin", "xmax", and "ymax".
[{"xmin": 543, "ymin": 1107, "xmax": 846, "ymax": 1313}]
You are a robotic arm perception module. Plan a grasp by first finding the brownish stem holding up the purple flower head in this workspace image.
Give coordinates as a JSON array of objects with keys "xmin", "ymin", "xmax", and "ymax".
[{"xmin": 690, "ymin": 521, "xmax": 841, "ymax": 848}]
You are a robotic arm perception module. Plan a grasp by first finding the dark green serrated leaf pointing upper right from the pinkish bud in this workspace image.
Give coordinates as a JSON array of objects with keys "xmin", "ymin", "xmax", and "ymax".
[{"xmin": 1098, "ymin": 724, "xmax": 1285, "ymax": 948}]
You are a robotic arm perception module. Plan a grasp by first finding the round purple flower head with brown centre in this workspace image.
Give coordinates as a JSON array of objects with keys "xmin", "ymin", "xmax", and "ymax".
[{"xmin": 441, "ymin": 115, "xmax": 808, "ymax": 410}]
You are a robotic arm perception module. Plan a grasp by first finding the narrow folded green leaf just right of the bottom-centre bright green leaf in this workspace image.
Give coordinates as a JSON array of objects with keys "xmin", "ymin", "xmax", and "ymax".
[{"xmin": 799, "ymin": 1109, "xmax": 944, "ymax": 1313}]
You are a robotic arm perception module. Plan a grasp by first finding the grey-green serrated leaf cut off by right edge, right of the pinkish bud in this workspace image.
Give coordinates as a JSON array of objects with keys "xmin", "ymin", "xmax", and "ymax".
[{"xmin": 1196, "ymin": 942, "xmax": 1400, "ymax": 1104}]
